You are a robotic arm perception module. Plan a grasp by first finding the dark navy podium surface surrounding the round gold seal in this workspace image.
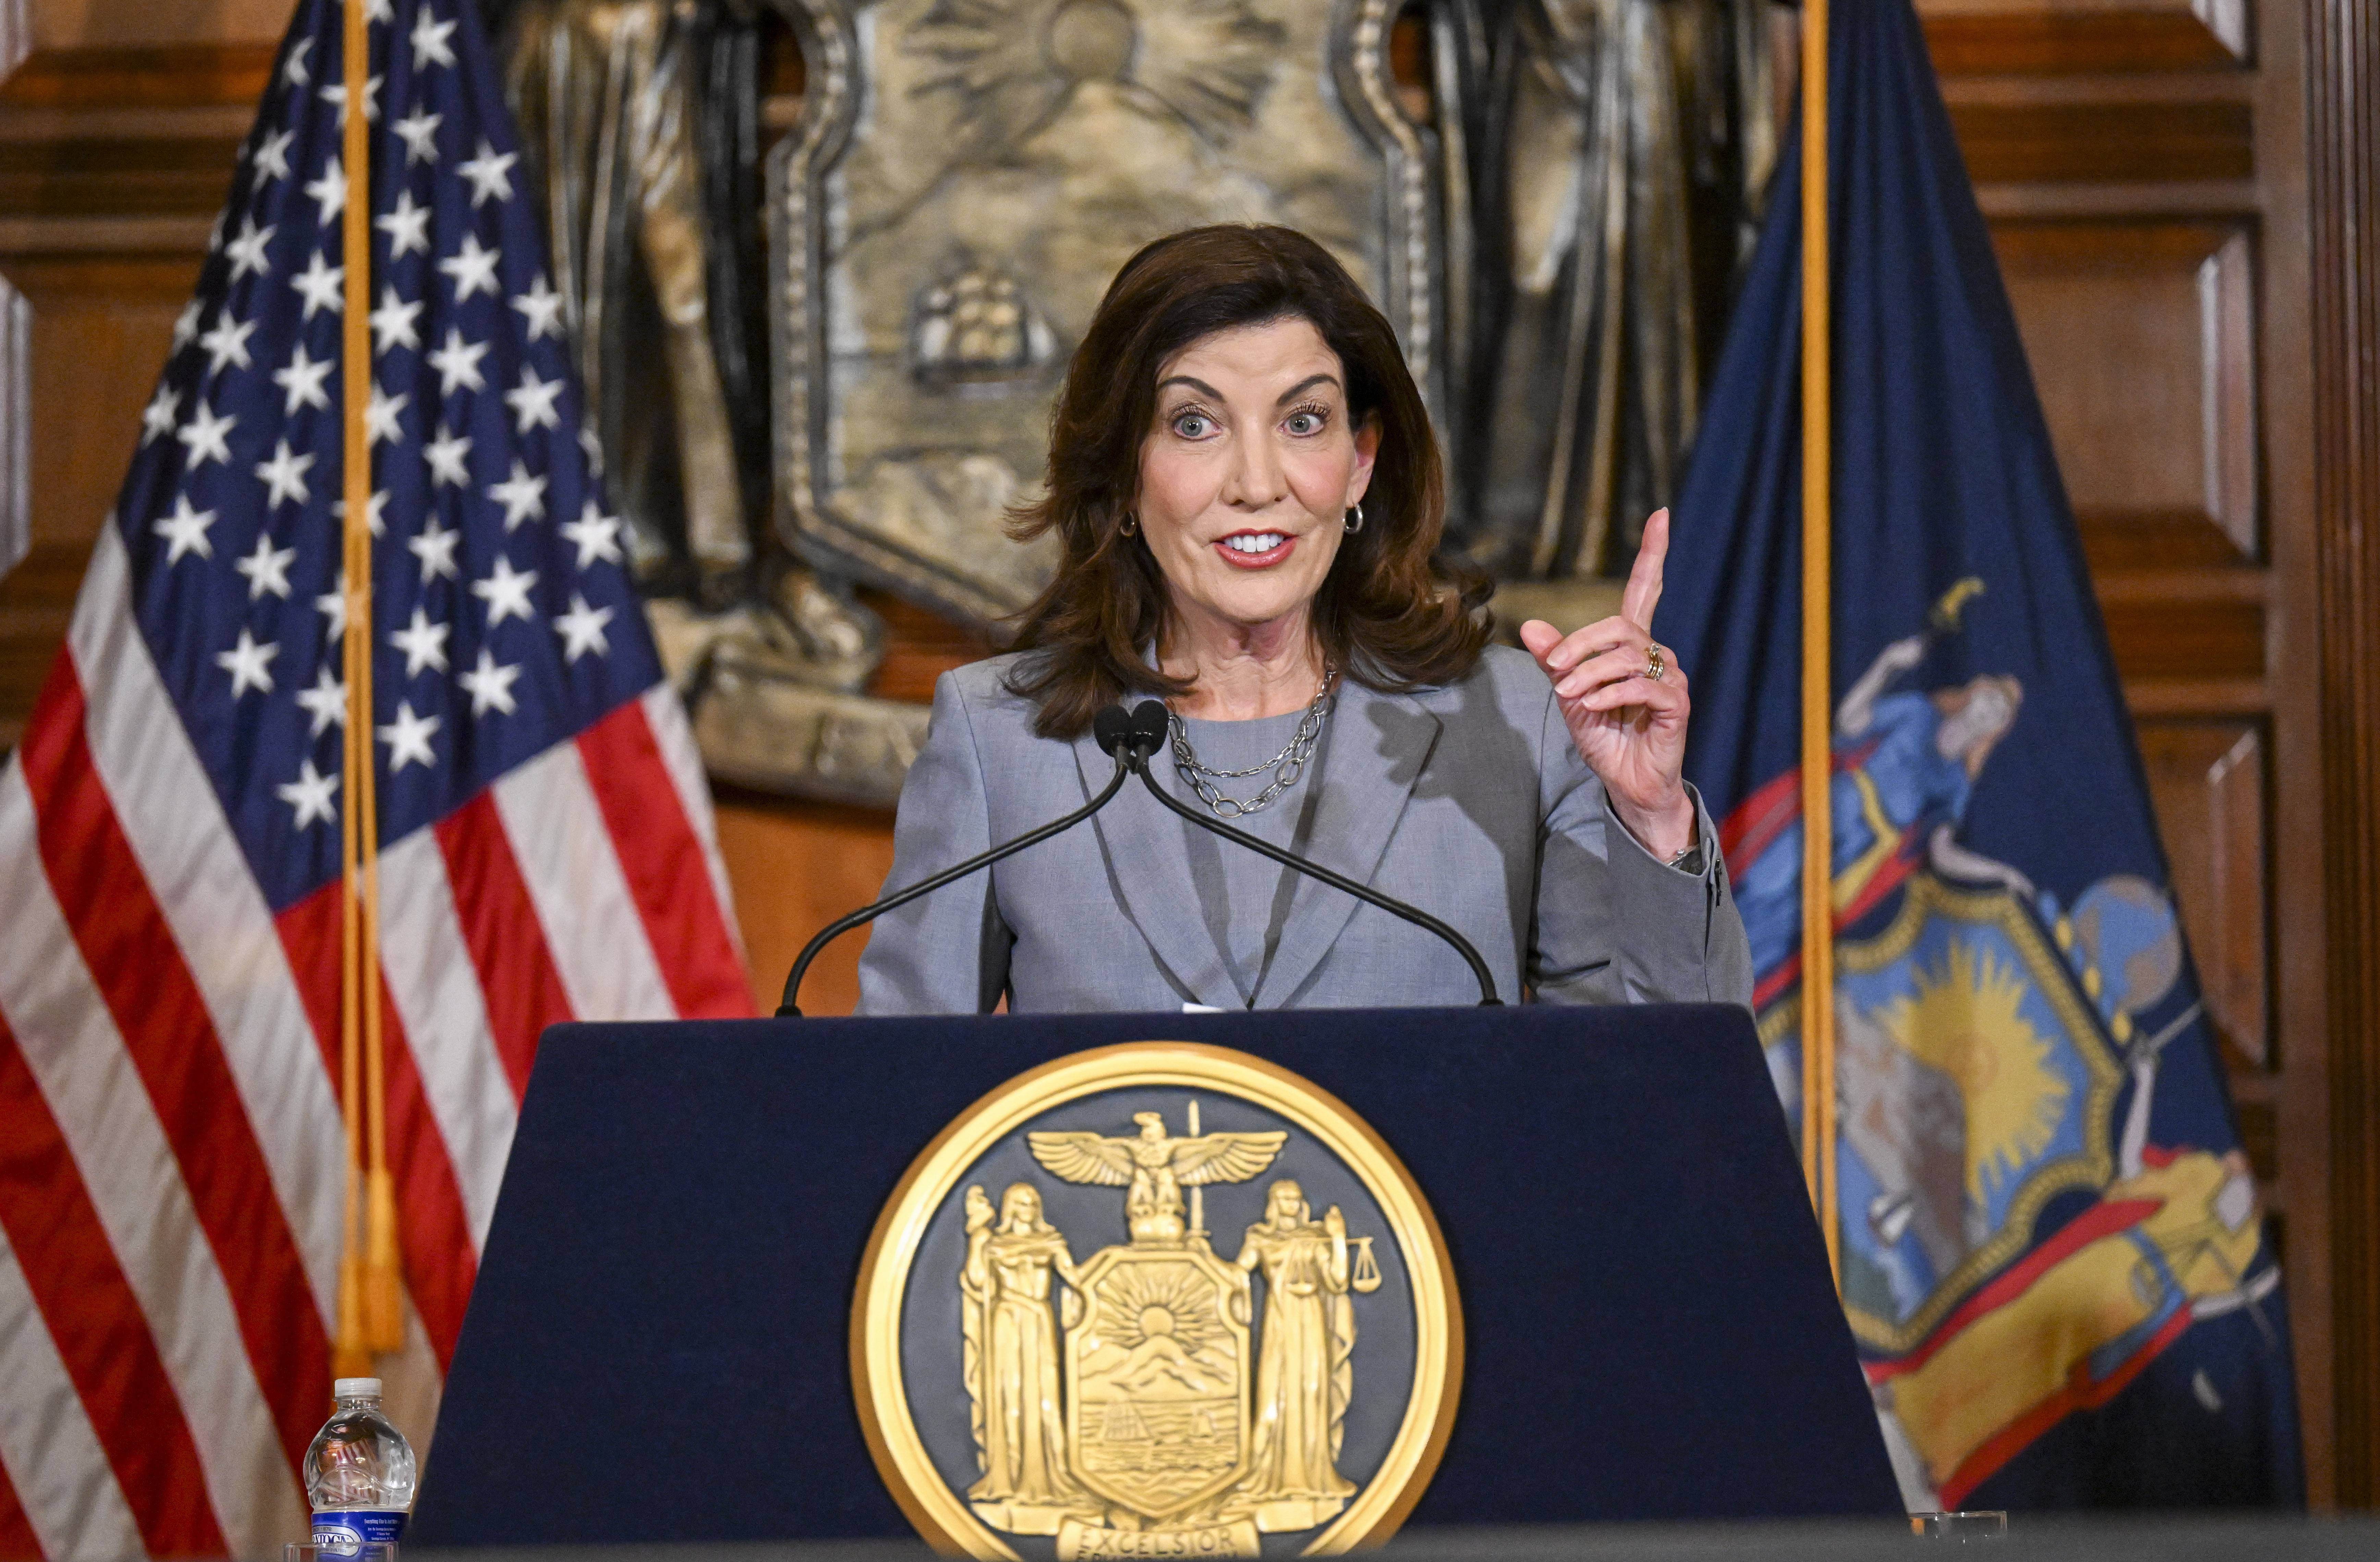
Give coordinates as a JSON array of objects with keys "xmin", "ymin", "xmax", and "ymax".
[{"xmin": 409, "ymin": 1005, "xmax": 1902, "ymax": 1545}]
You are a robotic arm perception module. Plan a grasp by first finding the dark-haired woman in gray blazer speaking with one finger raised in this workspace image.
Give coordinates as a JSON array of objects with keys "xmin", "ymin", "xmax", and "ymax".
[{"xmin": 859, "ymin": 226, "xmax": 1752, "ymax": 1014}]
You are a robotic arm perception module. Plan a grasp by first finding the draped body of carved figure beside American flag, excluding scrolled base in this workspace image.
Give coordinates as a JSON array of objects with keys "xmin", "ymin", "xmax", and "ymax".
[{"xmin": 495, "ymin": 0, "xmax": 766, "ymax": 595}]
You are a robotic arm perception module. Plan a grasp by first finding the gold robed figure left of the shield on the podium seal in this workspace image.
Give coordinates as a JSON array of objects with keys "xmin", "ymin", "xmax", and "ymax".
[{"xmin": 959, "ymin": 1183, "xmax": 1078, "ymax": 1505}]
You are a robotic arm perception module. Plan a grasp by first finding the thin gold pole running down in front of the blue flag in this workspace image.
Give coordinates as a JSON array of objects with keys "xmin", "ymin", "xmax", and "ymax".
[{"xmin": 1802, "ymin": 0, "xmax": 1842, "ymax": 1288}]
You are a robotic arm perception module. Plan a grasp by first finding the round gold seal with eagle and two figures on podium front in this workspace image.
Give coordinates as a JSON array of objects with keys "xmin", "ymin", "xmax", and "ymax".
[{"xmin": 852, "ymin": 1043, "xmax": 1461, "ymax": 1562}]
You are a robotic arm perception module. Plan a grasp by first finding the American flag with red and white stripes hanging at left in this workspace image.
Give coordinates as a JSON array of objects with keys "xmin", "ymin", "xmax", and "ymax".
[{"xmin": 0, "ymin": 0, "xmax": 752, "ymax": 1557}]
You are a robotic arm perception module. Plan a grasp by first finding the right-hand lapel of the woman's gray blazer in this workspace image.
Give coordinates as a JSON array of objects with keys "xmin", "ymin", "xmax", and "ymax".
[{"xmin": 1256, "ymin": 681, "xmax": 1442, "ymax": 1010}]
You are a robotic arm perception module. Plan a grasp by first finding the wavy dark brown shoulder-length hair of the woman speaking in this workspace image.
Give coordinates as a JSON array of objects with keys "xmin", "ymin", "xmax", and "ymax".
[{"xmin": 1009, "ymin": 224, "xmax": 1487, "ymax": 738}]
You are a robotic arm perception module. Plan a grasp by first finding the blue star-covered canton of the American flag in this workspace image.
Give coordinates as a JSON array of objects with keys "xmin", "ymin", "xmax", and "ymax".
[{"xmin": 108, "ymin": 0, "xmax": 659, "ymax": 902}]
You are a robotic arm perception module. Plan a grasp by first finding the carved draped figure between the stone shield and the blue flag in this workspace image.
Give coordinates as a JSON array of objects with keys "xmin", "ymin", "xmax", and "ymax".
[{"xmin": 1435, "ymin": 0, "xmax": 1775, "ymax": 578}]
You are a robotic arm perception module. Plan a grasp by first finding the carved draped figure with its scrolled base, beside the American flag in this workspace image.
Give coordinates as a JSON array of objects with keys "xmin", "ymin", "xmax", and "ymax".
[{"xmin": 486, "ymin": 0, "xmax": 926, "ymax": 803}]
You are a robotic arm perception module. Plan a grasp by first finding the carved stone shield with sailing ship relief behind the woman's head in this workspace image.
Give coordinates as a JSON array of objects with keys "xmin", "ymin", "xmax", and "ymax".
[{"xmin": 771, "ymin": 0, "xmax": 1442, "ymax": 624}]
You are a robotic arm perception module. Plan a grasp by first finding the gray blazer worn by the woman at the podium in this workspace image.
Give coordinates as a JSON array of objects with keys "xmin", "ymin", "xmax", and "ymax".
[{"xmin": 859, "ymin": 645, "xmax": 1752, "ymax": 1014}]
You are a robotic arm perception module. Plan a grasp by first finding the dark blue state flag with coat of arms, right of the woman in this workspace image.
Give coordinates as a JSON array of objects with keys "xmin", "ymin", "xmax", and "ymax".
[{"xmin": 1659, "ymin": 0, "xmax": 2304, "ymax": 1507}]
